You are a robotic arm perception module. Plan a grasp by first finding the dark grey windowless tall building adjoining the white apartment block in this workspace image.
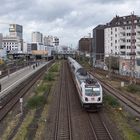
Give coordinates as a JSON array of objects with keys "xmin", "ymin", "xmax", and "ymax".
[{"xmin": 92, "ymin": 25, "xmax": 105, "ymax": 65}]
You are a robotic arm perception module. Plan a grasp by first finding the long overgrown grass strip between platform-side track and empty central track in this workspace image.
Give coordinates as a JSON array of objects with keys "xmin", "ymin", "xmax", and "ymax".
[{"xmin": 15, "ymin": 63, "xmax": 60, "ymax": 140}]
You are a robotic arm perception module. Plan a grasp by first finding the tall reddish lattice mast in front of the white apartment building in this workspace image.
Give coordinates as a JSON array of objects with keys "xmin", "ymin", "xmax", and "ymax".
[{"xmin": 130, "ymin": 13, "xmax": 136, "ymax": 84}]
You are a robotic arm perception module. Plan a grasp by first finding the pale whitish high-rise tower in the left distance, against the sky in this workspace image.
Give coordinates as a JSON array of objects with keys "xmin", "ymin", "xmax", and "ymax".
[{"xmin": 32, "ymin": 32, "xmax": 43, "ymax": 44}]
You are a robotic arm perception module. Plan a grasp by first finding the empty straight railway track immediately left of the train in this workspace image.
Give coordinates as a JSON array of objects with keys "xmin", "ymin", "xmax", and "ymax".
[{"xmin": 54, "ymin": 61, "xmax": 72, "ymax": 140}]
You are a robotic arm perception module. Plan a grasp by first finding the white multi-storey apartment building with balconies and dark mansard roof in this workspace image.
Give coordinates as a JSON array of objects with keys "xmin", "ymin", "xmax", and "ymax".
[{"xmin": 104, "ymin": 15, "xmax": 140, "ymax": 72}]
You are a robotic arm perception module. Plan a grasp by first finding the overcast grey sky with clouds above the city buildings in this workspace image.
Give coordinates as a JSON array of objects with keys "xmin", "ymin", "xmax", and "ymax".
[{"xmin": 0, "ymin": 0, "xmax": 140, "ymax": 47}]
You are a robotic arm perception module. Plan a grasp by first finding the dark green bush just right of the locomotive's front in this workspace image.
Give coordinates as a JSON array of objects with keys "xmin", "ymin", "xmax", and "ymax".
[{"xmin": 104, "ymin": 95, "xmax": 120, "ymax": 108}]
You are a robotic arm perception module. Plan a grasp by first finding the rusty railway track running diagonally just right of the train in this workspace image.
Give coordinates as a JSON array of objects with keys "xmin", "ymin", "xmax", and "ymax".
[{"xmin": 90, "ymin": 72, "xmax": 140, "ymax": 115}]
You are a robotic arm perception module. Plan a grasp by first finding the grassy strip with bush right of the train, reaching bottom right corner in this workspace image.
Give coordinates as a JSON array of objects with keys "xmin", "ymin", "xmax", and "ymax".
[{"xmin": 104, "ymin": 95, "xmax": 140, "ymax": 140}]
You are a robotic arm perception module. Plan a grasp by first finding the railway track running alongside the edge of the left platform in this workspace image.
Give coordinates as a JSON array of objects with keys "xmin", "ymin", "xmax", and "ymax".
[{"xmin": 0, "ymin": 61, "xmax": 53, "ymax": 121}]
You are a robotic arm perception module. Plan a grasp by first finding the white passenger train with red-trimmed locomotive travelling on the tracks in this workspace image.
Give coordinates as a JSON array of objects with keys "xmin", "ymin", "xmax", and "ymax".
[{"xmin": 68, "ymin": 57, "xmax": 103, "ymax": 111}]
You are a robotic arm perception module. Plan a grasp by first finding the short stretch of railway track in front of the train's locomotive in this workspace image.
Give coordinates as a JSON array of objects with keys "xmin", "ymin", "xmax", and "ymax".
[{"xmin": 88, "ymin": 113, "xmax": 113, "ymax": 140}]
